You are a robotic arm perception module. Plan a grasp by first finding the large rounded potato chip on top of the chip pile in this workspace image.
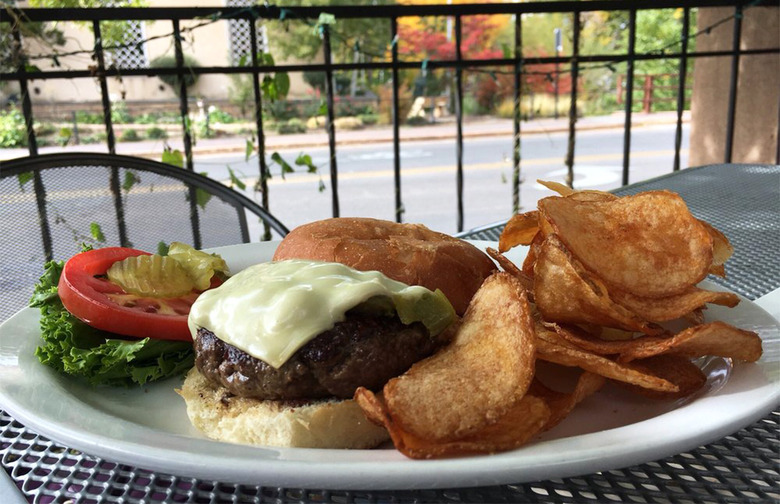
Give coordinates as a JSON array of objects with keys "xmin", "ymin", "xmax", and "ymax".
[{"xmin": 538, "ymin": 191, "xmax": 713, "ymax": 298}]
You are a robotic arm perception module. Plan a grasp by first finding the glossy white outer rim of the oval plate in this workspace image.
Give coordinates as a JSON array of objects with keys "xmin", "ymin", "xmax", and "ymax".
[{"xmin": 0, "ymin": 242, "xmax": 780, "ymax": 490}]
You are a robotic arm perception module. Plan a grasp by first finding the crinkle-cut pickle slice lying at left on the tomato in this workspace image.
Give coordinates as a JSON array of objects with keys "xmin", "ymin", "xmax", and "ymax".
[{"xmin": 106, "ymin": 254, "xmax": 195, "ymax": 298}]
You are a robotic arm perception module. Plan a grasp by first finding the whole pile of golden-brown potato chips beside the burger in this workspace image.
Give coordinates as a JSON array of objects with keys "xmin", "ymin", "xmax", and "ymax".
[{"xmin": 355, "ymin": 183, "xmax": 762, "ymax": 458}]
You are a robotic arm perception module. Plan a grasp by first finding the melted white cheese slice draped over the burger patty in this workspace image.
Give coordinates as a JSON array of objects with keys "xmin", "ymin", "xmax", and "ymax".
[{"xmin": 188, "ymin": 260, "xmax": 431, "ymax": 368}]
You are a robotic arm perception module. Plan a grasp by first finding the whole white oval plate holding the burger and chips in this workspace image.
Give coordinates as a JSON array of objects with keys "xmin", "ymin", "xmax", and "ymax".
[{"xmin": 0, "ymin": 243, "xmax": 780, "ymax": 490}]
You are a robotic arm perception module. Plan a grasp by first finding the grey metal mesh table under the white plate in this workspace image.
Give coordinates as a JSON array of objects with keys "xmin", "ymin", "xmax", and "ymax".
[{"xmin": 0, "ymin": 165, "xmax": 780, "ymax": 503}]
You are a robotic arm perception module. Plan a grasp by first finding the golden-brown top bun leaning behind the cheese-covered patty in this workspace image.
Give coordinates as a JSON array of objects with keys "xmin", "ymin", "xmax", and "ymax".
[{"xmin": 273, "ymin": 217, "xmax": 496, "ymax": 315}]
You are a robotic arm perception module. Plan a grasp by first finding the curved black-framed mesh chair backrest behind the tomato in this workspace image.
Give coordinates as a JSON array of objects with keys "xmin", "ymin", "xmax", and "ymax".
[{"xmin": 0, "ymin": 153, "xmax": 288, "ymax": 321}]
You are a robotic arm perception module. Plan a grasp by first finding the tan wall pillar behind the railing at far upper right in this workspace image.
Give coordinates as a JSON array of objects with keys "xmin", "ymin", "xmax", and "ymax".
[{"xmin": 689, "ymin": 7, "xmax": 780, "ymax": 166}]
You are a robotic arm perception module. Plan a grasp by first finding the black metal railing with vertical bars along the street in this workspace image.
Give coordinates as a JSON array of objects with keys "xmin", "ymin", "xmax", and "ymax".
[{"xmin": 0, "ymin": 0, "xmax": 780, "ymax": 236}]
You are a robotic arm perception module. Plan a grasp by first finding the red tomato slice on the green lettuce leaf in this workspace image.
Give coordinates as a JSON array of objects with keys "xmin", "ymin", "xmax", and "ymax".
[{"xmin": 57, "ymin": 247, "xmax": 199, "ymax": 341}]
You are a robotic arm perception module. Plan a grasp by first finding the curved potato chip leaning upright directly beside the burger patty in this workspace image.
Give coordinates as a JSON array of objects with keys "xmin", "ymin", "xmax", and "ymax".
[{"xmin": 383, "ymin": 272, "xmax": 535, "ymax": 441}]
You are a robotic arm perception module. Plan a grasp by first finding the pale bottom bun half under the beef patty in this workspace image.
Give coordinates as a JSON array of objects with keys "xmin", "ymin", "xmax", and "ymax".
[{"xmin": 176, "ymin": 368, "xmax": 389, "ymax": 449}]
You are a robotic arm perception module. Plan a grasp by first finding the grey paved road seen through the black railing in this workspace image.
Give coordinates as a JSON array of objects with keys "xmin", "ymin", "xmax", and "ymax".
[{"xmin": 195, "ymin": 125, "xmax": 688, "ymax": 233}]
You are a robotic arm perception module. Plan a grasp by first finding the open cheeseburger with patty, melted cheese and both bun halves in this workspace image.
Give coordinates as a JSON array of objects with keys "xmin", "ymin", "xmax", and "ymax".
[{"xmin": 179, "ymin": 218, "xmax": 495, "ymax": 448}]
